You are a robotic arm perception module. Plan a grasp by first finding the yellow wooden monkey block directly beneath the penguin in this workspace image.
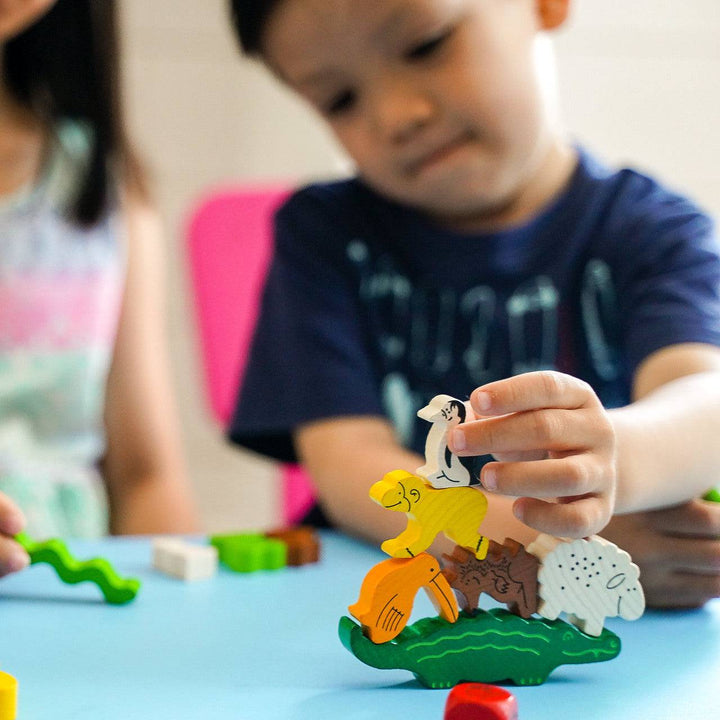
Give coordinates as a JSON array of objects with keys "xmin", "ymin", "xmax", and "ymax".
[{"xmin": 370, "ymin": 470, "xmax": 488, "ymax": 560}]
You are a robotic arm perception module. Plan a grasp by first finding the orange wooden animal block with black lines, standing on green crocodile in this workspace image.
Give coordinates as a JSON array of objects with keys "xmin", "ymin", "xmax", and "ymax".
[{"xmin": 348, "ymin": 553, "xmax": 458, "ymax": 643}]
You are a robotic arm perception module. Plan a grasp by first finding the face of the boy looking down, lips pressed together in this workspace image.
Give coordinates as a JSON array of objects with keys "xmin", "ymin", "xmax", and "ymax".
[{"xmin": 263, "ymin": 0, "xmax": 568, "ymax": 227}]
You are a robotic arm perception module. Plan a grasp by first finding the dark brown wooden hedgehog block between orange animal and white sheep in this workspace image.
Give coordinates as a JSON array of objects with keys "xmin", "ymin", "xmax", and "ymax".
[{"xmin": 443, "ymin": 538, "xmax": 539, "ymax": 618}]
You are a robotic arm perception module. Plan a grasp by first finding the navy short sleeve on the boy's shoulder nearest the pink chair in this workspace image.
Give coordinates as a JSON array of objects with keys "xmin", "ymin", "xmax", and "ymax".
[{"xmin": 229, "ymin": 191, "xmax": 383, "ymax": 462}]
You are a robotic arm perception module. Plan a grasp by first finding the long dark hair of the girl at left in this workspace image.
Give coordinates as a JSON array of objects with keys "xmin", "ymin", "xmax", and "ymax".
[{"xmin": 3, "ymin": 0, "xmax": 147, "ymax": 225}]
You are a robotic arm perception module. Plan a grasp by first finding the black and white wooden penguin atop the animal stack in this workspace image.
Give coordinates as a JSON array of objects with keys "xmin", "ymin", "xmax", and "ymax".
[{"xmin": 415, "ymin": 395, "xmax": 480, "ymax": 488}]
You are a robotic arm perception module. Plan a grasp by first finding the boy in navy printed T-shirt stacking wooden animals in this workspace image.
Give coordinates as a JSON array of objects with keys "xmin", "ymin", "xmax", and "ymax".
[{"xmin": 231, "ymin": 0, "xmax": 720, "ymax": 605}]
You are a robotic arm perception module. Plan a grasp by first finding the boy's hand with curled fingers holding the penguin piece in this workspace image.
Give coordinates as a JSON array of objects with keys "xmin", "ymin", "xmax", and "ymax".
[{"xmin": 449, "ymin": 371, "xmax": 616, "ymax": 538}]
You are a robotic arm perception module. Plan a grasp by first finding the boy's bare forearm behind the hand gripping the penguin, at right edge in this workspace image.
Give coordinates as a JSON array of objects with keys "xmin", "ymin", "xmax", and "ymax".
[{"xmin": 610, "ymin": 371, "xmax": 720, "ymax": 513}]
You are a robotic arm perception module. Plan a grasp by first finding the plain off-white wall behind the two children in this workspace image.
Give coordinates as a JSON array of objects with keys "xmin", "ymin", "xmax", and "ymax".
[{"xmin": 120, "ymin": 0, "xmax": 720, "ymax": 531}]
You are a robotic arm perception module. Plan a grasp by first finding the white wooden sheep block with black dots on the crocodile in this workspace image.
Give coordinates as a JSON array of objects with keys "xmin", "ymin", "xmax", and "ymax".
[{"xmin": 526, "ymin": 535, "xmax": 645, "ymax": 636}]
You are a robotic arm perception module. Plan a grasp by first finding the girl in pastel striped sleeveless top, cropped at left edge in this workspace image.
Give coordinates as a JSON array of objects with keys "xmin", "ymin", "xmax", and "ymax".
[{"xmin": 0, "ymin": 0, "xmax": 196, "ymax": 574}]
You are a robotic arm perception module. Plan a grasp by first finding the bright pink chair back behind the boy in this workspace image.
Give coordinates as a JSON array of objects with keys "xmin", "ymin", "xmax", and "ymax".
[{"xmin": 187, "ymin": 186, "xmax": 313, "ymax": 524}]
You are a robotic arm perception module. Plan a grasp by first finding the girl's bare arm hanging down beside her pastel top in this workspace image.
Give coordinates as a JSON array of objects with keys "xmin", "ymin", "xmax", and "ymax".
[{"xmin": 102, "ymin": 193, "xmax": 198, "ymax": 534}]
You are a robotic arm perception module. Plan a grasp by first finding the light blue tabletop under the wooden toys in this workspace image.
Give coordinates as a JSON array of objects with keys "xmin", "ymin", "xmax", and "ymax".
[{"xmin": 0, "ymin": 533, "xmax": 720, "ymax": 720}]
